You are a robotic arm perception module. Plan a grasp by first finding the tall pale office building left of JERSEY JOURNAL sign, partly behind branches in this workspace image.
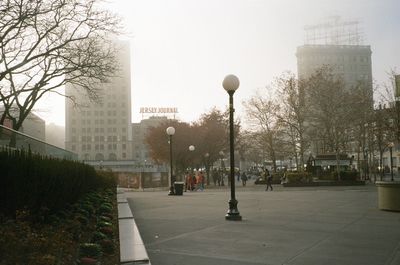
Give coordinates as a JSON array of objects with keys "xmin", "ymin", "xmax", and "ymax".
[{"xmin": 65, "ymin": 42, "xmax": 132, "ymax": 161}]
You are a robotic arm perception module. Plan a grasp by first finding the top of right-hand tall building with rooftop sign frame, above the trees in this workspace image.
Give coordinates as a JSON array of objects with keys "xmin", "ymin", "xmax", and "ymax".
[{"xmin": 296, "ymin": 16, "xmax": 372, "ymax": 92}]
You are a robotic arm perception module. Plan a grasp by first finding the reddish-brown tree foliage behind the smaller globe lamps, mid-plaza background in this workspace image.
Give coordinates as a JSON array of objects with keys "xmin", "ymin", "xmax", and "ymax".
[{"xmin": 146, "ymin": 109, "xmax": 228, "ymax": 175}]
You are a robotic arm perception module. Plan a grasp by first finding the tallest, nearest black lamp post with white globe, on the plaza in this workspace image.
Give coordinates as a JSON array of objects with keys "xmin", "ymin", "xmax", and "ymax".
[{"xmin": 222, "ymin": 75, "xmax": 242, "ymax": 221}]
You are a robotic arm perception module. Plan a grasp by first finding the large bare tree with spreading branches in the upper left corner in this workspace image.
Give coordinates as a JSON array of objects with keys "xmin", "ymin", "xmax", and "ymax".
[{"xmin": 0, "ymin": 0, "xmax": 121, "ymax": 133}]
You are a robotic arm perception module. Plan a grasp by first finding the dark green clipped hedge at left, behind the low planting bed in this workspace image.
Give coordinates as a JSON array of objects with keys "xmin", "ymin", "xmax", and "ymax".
[{"xmin": 0, "ymin": 148, "xmax": 116, "ymax": 216}]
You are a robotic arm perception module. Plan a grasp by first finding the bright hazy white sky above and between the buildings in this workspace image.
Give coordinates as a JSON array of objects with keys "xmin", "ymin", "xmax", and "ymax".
[{"xmin": 38, "ymin": 0, "xmax": 400, "ymax": 125}]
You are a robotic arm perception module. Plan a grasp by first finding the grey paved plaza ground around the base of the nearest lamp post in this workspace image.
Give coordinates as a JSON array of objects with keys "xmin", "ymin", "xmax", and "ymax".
[{"xmin": 126, "ymin": 184, "xmax": 400, "ymax": 265}]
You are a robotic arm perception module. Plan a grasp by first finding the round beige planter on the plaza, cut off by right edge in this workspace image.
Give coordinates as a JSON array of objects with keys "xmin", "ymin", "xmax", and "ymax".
[{"xmin": 376, "ymin": 181, "xmax": 400, "ymax": 212}]
